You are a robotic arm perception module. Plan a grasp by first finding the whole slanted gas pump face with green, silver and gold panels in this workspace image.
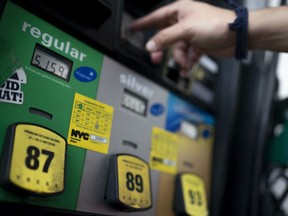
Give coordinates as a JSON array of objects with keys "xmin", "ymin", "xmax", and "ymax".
[{"xmin": 0, "ymin": 1, "xmax": 215, "ymax": 216}]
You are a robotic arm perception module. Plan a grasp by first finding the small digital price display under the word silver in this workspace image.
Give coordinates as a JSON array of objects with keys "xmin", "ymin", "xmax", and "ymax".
[{"xmin": 121, "ymin": 89, "xmax": 148, "ymax": 116}]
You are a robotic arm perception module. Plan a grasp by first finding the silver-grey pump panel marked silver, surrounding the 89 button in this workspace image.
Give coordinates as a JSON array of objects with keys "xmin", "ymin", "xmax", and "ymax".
[{"xmin": 77, "ymin": 57, "xmax": 169, "ymax": 216}]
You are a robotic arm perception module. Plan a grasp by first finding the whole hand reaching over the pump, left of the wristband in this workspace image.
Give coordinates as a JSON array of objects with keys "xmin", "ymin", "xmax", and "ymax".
[{"xmin": 131, "ymin": 0, "xmax": 236, "ymax": 74}]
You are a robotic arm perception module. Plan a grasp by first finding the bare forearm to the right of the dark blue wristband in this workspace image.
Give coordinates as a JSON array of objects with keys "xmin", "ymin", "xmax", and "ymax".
[{"xmin": 248, "ymin": 6, "xmax": 288, "ymax": 52}]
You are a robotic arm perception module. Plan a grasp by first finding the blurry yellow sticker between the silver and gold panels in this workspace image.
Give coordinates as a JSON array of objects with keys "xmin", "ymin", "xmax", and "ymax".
[{"xmin": 150, "ymin": 127, "xmax": 178, "ymax": 174}]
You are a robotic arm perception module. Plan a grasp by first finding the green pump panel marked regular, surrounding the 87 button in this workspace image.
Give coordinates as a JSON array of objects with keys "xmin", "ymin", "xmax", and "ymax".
[{"xmin": 0, "ymin": 1, "xmax": 103, "ymax": 210}]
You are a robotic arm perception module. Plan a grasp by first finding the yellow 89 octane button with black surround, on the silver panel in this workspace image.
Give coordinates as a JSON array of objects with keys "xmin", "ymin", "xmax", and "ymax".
[{"xmin": 105, "ymin": 154, "xmax": 152, "ymax": 211}]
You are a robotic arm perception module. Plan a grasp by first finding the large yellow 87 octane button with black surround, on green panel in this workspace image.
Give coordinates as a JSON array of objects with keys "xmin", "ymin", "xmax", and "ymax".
[{"xmin": 0, "ymin": 123, "xmax": 67, "ymax": 196}]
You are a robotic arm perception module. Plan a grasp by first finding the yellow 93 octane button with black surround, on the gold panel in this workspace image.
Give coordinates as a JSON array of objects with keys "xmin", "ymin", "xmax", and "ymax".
[{"xmin": 173, "ymin": 173, "xmax": 208, "ymax": 216}]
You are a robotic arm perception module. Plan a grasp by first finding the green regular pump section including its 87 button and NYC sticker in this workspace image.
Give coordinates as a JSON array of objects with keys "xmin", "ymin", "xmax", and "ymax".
[{"xmin": 0, "ymin": 1, "xmax": 113, "ymax": 209}]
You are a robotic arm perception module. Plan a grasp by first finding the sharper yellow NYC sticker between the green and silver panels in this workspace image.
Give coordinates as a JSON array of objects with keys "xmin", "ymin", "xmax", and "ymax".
[{"xmin": 68, "ymin": 93, "xmax": 113, "ymax": 154}]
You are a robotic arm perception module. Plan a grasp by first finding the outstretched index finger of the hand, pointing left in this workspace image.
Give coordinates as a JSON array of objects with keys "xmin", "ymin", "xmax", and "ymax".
[{"xmin": 131, "ymin": 2, "xmax": 178, "ymax": 30}]
